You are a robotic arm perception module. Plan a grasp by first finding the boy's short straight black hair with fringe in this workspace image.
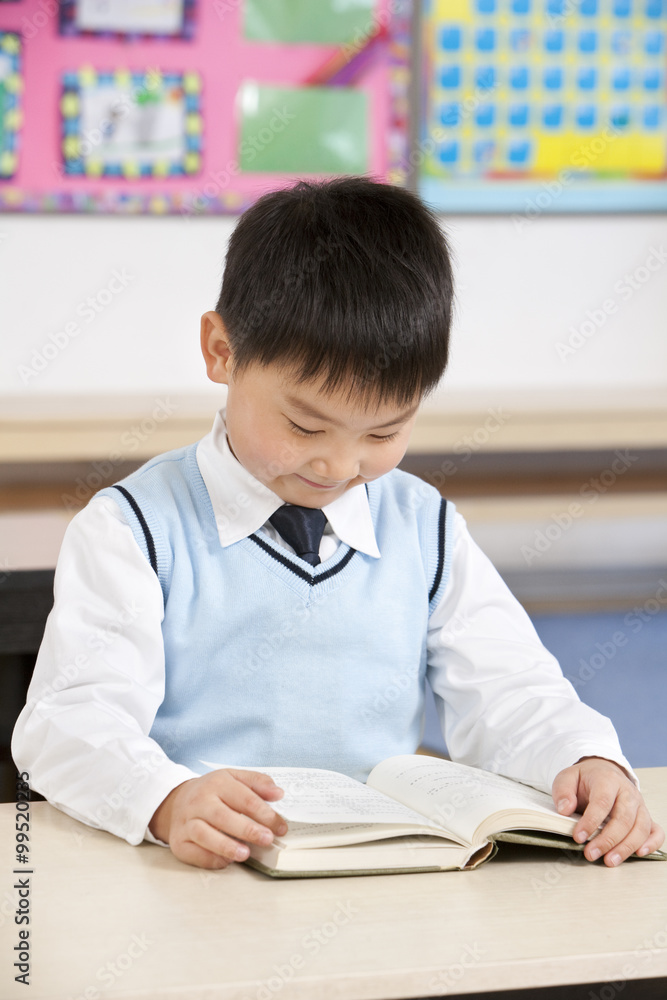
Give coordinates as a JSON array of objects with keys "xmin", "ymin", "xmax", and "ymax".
[{"xmin": 216, "ymin": 177, "xmax": 453, "ymax": 406}]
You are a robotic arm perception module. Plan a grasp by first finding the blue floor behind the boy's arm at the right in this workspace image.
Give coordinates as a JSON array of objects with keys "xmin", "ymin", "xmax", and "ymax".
[{"xmin": 422, "ymin": 602, "xmax": 667, "ymax": 767}]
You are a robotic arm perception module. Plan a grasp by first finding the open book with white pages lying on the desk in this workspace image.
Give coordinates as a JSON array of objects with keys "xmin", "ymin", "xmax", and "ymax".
[{"xmin": 204, "ymin": 754, "xmax": 667, "ymax": 878}]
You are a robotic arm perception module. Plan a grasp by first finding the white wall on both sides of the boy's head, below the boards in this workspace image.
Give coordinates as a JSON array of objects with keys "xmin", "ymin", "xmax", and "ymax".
[{"xmin": 0, "ymin": 215, "xmax": 667, "ymax": 407}]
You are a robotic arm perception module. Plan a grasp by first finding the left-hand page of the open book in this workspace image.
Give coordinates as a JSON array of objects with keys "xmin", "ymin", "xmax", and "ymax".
[{"xmin": 202, "ymin": 761, "xmax": 438, "ymax": 828}]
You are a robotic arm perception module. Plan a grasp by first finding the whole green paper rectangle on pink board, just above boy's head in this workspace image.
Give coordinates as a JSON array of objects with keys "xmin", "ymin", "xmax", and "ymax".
[{"xmin": 239, "ymin": 81, "xmax": 369, "ymax": 174}]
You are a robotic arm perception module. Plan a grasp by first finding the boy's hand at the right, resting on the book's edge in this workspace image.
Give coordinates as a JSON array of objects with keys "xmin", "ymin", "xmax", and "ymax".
[{"xmin": 551, "ymin": 757, "xmax": 665, "ymax": 868}]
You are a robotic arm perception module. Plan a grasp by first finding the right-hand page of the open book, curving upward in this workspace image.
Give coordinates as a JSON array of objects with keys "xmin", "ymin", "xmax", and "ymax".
[{"xmin": 368, "ymin": 755, "xmax": 578, "ymax": 843}]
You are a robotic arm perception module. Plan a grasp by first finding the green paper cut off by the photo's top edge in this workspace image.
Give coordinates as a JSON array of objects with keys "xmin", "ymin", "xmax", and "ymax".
[{"xmin": 244, "ymin": 0, "xmax": 375, "ymax": 45}]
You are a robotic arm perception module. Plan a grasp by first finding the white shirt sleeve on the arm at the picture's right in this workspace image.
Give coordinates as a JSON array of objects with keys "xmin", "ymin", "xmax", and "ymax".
[{"xmin": 427, "ymin": 514, "xmax": 638, "ymax": 791}]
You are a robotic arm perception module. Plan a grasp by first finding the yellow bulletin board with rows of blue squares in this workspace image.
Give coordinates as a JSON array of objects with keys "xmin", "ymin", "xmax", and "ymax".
[{"xmin": 419, "ymin": 0, "xmax": 667, "ymax": 218}]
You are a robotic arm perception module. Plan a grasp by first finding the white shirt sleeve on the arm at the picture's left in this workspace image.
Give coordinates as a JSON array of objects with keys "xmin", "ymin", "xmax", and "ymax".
[{"xmin": 12, "ymin": 497, "xmax": 195, "ymax": 844}]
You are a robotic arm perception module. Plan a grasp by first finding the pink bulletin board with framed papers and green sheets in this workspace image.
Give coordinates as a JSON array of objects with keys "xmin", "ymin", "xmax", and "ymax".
[{"xmin": 0, "ymin": 0, "xmax": 410, "ymax": 215}]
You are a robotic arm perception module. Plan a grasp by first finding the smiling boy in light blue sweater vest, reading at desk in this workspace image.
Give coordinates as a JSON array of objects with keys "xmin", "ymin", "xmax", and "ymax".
[{"xmin": 13, "ymin": 178, "xmax": 663, "ymax": 868}]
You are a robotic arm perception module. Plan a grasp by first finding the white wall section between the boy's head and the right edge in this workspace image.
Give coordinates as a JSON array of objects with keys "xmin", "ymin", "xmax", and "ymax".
[{"xmin": 436, "ymin": 216, "xmax": 667, "ymax": 406}]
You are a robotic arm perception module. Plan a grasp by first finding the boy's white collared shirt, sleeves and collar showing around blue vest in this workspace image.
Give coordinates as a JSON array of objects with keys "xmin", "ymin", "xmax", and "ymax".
[{"xmin": 12, "ymin": 411, "xmax": 637, "ymax": 843}]
